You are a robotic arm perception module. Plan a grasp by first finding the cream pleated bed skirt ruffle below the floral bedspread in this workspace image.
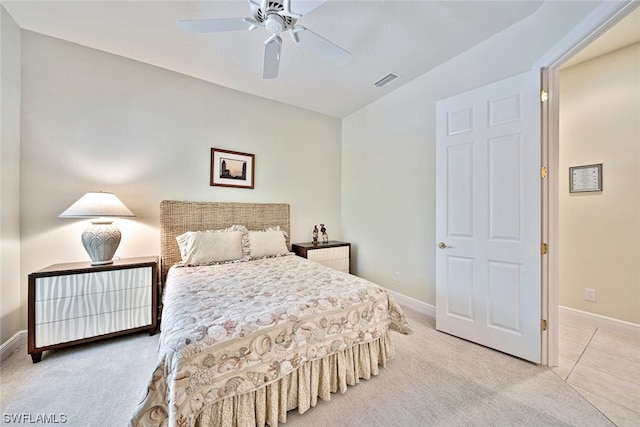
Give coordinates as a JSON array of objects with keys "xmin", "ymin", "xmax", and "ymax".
[{"xmin": 196, "ymin": 332, "xmax": 395, "ymax": 427}]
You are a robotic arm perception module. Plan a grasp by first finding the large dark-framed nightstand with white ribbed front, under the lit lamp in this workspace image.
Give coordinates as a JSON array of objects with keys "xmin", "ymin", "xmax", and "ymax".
[{"xmin": 27, "ymin": 257, "xmax": 159, "ymax": 363}]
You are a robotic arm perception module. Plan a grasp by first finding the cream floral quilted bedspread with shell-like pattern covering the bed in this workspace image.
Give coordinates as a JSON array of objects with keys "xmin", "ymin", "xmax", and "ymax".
[{"xmin": 131, "ymin": 255, "xmax": 412, "ymax": 426}]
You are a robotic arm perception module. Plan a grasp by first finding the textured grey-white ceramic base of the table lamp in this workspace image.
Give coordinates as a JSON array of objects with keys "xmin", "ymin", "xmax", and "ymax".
[{"xmin": 82, "ymin": 218, "xmax": 122, "ymax": 265}]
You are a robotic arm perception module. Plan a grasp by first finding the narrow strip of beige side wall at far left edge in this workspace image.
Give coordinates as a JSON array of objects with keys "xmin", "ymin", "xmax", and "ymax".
[{"xmin": 0, "ymin": 6, "xmax": 22, "ymax": 344}]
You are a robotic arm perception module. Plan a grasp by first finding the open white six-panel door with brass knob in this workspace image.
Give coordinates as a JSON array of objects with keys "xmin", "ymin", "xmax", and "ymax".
[{"xmin": 435, "ymin": 71, "xmax": 542, "ymax": 363}]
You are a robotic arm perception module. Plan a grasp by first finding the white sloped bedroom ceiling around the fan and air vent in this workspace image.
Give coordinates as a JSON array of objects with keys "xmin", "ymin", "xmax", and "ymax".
[{"xmin": 5, "ymin": 0, "xmax": 640, "ymax": 117}]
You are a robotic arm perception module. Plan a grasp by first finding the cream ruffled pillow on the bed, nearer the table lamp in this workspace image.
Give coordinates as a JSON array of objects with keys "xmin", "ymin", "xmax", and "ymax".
[{"xmin": 176, "ymin": 225, "xmax": 250, "ymax": 266}]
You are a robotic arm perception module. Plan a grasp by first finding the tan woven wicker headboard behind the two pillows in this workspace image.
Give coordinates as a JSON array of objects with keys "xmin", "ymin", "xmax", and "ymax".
[{"xmin": 160, "ymin": 200, "xmax": 290, "ymax": 283}]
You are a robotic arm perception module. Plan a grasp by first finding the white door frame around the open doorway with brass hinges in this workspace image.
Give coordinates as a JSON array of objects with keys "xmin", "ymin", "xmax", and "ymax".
[{"xmin": 534, "ymin": 0, "xmax": 640, "ymax": 366}]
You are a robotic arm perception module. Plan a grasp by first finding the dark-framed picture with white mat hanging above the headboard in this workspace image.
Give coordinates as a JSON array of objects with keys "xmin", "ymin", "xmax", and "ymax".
[{"xmin": 211, "ymin": 148, "xmax": 255, "ymax": 188}]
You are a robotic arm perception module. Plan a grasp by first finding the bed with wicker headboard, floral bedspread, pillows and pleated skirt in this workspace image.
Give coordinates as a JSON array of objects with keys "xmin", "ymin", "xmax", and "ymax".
[{"xmin": 130, "ymin": 200, "xmax": 412, "ymax": 427}]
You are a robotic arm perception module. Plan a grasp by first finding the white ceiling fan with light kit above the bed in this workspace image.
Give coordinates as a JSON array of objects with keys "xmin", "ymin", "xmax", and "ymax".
[{"xmin": 178, "ymin": 0, "xmax": 351, "ymax": 79}]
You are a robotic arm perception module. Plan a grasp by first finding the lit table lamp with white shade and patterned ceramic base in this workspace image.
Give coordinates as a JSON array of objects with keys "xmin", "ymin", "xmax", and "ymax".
[{"xmin": 58, "ymin": 191, "xmax": 135, "ymax": 265}]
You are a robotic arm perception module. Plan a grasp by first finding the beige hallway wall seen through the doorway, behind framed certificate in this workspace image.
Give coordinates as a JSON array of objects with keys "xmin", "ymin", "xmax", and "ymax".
[{"xmin": 559, "ymin": 43, "xmax": 640, "ymax": 323}]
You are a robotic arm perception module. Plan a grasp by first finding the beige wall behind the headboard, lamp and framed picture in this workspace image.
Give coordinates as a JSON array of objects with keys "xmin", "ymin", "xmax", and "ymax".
[{"xmin": 15, "ymin": 31, "xmax": 341, "ymax": 334}]
